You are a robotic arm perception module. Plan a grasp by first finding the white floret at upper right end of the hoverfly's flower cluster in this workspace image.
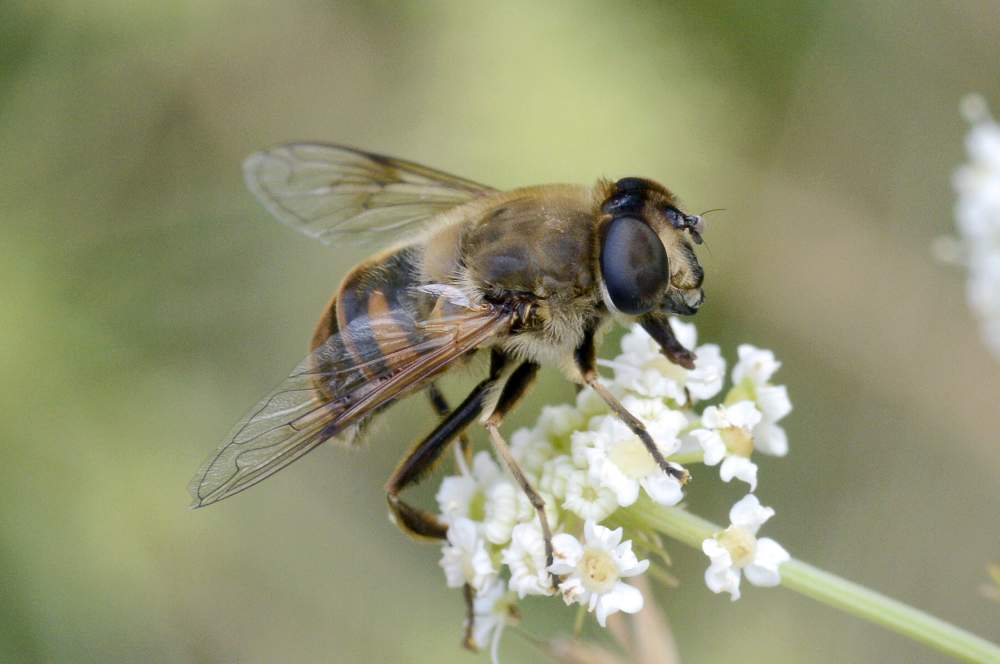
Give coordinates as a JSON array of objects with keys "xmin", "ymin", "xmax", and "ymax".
[{"xmin": 727, "ymin": 344, "xmax": 792, "ymax": 456}]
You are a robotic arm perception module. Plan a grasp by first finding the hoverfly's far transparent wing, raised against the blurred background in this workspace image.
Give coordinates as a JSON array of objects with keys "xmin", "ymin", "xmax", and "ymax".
[{"xmin": 243, "ymin": 143, "xmax": 495, "ymax": 242}]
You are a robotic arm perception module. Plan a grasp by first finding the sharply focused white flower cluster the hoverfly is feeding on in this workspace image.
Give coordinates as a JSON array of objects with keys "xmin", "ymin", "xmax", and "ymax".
[{"xmin": 437, "ymin": 319, "xmax": 792, "ymax": 649}]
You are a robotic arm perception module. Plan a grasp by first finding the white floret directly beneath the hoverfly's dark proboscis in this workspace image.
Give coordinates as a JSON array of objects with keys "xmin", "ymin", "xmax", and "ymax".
[{"xmin": 603, "ymin": 318, "xmax": 726, "ymax": 406}]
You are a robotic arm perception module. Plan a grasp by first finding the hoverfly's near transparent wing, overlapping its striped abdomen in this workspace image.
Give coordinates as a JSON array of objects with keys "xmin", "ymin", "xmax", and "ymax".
[{"xmin": 189, "ymin": 299, "xmax": 514, "ymax": 507}]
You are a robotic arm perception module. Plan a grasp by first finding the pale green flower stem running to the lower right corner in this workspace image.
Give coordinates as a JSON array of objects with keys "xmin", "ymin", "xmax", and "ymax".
[{"xmin": 632, "ymin": 497, "xmax": 1000, "ymax": 662}]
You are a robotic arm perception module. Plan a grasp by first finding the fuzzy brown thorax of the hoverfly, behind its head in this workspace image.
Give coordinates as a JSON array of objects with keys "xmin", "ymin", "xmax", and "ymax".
[{"xmin": 423, "ymin": 185, "xmax": 605, "ymax": 368}]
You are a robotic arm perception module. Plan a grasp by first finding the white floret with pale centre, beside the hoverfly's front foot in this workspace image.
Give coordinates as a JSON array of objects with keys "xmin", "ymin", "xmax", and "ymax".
[{"xmin": 573, "ymin": 415, "xmax": 684, "ymax": 507}]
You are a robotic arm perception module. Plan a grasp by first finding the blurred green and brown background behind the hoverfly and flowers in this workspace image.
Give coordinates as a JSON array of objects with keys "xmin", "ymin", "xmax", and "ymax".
[{"xmin": 0, "ymin": 0, "xmax": 1000, "ymax": 662}]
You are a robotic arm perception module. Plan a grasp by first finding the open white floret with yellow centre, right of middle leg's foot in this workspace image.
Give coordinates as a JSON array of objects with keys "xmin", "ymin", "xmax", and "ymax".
[{"xmin": 549, "ymin": 521, "xmax": 649, "ymax": 627}]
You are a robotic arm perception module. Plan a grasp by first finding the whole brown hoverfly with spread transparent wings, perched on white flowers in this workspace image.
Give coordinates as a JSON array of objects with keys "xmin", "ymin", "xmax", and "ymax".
[{"xmin": 190, "ymin": 144, "xmax": 704, "ymax": 644}]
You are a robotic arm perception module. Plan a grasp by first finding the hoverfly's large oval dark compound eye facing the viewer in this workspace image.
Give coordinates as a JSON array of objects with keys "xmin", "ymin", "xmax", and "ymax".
[{"xmin": 601, "ymin": 217, "xmax": 670, "ymax": 316}]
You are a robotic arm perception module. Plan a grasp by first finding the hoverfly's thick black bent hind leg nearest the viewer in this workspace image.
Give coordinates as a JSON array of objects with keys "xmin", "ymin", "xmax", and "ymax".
[{"xmin": 385, "ymin": 363, "xmax": 503, "ymax": 539}]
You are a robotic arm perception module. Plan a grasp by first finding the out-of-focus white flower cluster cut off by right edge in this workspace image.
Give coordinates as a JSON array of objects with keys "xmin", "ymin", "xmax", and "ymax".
[{"xmin": 937, "ymin": 95, "xmax": 1000, "ymax": 358}]
